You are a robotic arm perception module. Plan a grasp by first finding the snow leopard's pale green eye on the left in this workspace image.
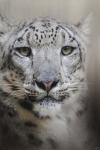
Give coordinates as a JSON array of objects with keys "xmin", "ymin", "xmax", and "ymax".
[{"xmin": 15, "ymin": 47, "xmax": 31, "ymax": 57}]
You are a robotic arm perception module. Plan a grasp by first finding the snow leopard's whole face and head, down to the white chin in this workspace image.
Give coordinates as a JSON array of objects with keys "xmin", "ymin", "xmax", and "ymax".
[{"xmin": 0, "ymin": 18, "xmax": 89, "ymax": 117}]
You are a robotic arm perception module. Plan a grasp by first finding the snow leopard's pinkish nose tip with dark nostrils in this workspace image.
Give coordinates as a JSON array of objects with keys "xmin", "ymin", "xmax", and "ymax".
[{"xmin": 35, "ymin": 80, "xmax": 59, "ymax": 92}]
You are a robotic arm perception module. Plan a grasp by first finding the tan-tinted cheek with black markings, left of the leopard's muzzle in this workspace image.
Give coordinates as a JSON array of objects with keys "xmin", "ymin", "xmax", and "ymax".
[{"xmin": 0, "ymin": 71, "xmax": 25, "ymax": 99}]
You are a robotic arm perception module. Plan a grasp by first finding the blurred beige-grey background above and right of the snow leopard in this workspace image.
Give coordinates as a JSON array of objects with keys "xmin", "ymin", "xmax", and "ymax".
[{"xmin": 0, "ymin": 0, "xmax": 100, "ymax": 138}]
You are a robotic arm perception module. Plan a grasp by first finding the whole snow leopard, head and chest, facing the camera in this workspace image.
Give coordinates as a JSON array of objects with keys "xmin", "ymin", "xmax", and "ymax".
[{"xmin": 0, "ymin": 17, "xmax": 89, "ymax": 150}]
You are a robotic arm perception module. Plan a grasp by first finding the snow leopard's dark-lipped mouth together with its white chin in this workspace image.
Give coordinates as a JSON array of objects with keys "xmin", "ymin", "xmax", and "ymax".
[{"xmin": 33, "ymin": 96, "xmax": 63, "ymax": 118}]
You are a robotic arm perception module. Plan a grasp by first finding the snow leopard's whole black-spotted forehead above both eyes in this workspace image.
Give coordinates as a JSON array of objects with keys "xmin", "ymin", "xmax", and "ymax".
[{"xmin": 15, "ymin": 19, "xmax": 70, "ymax": 46}]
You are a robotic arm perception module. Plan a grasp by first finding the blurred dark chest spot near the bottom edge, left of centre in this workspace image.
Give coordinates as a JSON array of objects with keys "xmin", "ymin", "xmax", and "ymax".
[{"xmin": 28, "ymin": 133, "xmax": 43, "ymax": 147}]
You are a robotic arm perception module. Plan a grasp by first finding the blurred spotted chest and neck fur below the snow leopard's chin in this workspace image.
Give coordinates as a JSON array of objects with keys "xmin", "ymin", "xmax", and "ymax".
[{"xmin": 0, "ymin": 92, "xmax": 88, "ymax": 150}]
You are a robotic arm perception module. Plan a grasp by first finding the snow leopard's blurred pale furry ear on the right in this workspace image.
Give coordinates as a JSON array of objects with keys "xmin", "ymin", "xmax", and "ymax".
[{"xmin": 76, "ymin": 13, "xmax": 92, "ymax": 36}]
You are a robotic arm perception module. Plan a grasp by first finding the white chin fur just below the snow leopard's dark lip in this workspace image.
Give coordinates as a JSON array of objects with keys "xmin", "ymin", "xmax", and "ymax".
[{"xmin": 34, "ymin": 102, "xmax": 61, "ymax": 117}]
